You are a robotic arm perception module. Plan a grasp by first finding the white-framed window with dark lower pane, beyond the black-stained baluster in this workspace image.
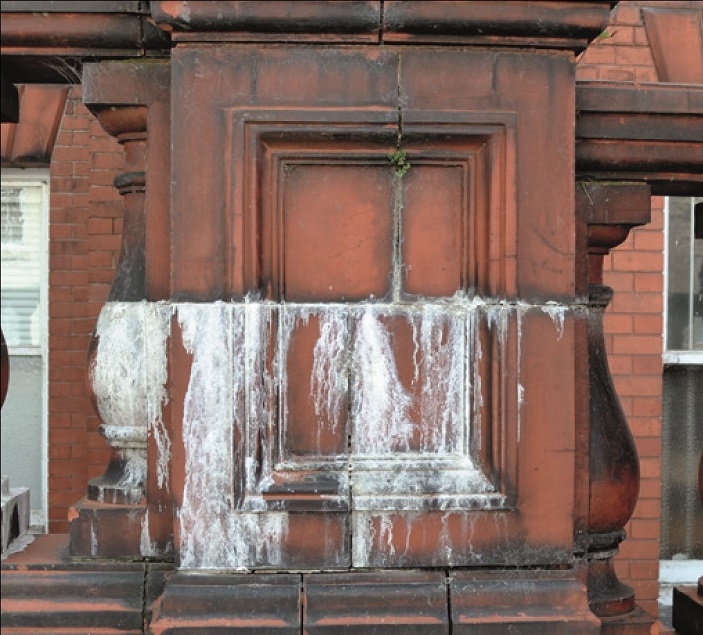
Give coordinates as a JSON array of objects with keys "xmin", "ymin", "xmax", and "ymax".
[{"xmin": 660, "ymin": 197, "xmax": 703, "ymax": 615}]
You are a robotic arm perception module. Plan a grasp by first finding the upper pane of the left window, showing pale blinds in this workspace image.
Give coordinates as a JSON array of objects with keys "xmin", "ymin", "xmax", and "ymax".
[{"xmin": 1, "ymin": 183, "xmax": 45, "ymax": 347}]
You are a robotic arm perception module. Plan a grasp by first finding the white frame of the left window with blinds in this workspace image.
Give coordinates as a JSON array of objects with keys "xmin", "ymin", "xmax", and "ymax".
[{"xmin": 2, "ymin": 168, "xmax": 51, "ymax": 531}]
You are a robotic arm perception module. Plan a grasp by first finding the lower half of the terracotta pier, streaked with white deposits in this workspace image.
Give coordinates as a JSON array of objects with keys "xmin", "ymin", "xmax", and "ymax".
[{"xmin": 171, "ymin": 300, "xmax": 574, "ymax": 568}]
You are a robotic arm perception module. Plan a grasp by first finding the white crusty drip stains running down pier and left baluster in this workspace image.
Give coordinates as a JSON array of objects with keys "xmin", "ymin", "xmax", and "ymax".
[{"xmin": 92, "ymin": 294, "xmax": 571, "ymax": 570}]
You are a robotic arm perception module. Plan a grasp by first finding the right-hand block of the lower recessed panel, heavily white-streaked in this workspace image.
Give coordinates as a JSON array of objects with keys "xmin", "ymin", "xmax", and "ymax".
[{"xmin": 351, "ymin": 306, "xmax": 470, "ymax": 458}]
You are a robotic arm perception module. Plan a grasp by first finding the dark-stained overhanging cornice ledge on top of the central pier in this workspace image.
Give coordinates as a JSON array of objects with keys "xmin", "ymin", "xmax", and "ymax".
[{"xmin": 150, "ymin": 0, "xmax": 616, "ymax": 51}]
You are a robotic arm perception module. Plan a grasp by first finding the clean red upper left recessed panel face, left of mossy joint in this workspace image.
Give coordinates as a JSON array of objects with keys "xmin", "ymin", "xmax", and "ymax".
[{"xmin": 282, "ymin": 162, "xmax": 394, "ymax": 302}]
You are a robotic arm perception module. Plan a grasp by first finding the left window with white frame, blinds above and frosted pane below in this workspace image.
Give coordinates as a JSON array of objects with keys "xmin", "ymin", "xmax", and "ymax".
[{"xmin": 0, "ymin": 170, "xmax": 49, "ymax": 527}]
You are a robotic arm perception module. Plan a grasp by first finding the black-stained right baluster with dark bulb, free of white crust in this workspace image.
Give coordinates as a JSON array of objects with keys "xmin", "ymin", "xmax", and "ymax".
[{"xmin": 576, "ymin": 182, "xmax": 650, "ymax": 617}]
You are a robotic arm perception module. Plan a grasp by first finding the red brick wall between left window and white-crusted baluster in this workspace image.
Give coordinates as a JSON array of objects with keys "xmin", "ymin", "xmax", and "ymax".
[{"xmin": 48, "ymin": 87, "xmax": 123, "ymax": 532}]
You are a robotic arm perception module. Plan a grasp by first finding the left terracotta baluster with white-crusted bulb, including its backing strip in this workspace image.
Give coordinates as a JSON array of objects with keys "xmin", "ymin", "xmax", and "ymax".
[{"xmin": 70, "ymin": 62, "xmax": 172, "ymax": 556}]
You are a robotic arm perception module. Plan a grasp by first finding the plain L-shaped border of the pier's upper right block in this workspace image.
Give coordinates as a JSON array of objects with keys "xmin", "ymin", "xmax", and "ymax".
[{"xmin": 399, "ymin": 49, "xmax": 575, "ymax": 299}]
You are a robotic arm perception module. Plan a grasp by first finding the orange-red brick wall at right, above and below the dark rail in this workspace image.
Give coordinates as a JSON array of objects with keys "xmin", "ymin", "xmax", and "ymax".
[{"xmin": 576, "ymin": 2, "xmax": 667, "ymax": 615}]
